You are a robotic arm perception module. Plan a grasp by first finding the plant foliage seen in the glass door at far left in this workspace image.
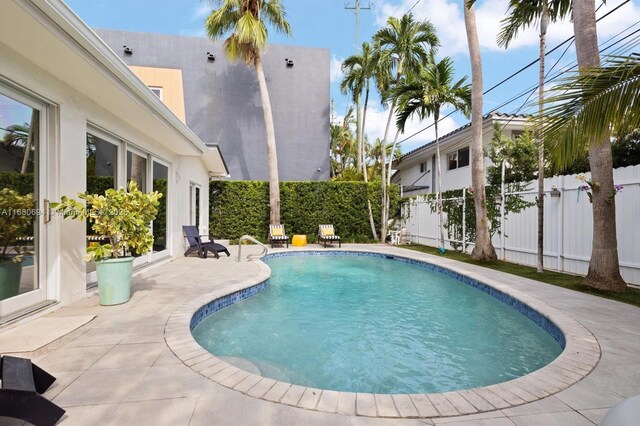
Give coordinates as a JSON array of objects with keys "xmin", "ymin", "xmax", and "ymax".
[{"xmin": 0, "ymin": 188, "xmax": 35, "ymax": 263}]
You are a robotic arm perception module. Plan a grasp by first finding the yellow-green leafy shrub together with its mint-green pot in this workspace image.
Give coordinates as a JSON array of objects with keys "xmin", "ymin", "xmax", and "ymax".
[{"xmin": 52, "ymin": 181, "xmax": 162, "ymax": 305}]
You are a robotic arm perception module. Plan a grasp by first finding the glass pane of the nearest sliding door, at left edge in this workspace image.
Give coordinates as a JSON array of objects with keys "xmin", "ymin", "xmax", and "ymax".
[{"xmin": 0, "ymin": 94, "xmax": 40, "ymax": 301}]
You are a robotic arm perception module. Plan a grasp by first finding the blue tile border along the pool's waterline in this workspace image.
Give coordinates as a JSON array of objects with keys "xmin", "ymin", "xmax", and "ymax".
[{"xmin": 190, "ymin": 250, "xmax": 566, "ymax": 349}]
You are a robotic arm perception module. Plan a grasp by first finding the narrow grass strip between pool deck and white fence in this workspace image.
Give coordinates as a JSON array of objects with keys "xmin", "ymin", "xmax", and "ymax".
[{"xmin": 398, "ymin": 244, "xmax": 640, "ymax": 307}]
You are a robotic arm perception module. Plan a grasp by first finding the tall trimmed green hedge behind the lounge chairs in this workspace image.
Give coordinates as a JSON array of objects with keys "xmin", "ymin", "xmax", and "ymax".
[{"xmin": 209, "ymin": 181, "xmax": 400, "ymax": 242}]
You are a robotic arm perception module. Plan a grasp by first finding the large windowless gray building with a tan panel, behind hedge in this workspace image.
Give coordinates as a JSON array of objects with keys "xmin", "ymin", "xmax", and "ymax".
[{"xmin": 96, "ymin": 30, "xmax": 330, "ymax": 180}]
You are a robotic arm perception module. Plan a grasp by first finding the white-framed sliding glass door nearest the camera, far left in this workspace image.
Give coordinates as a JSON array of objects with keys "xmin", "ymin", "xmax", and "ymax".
[{"xmin": 0, "ymin": 85, "xmax": 50, "ymax": 323}]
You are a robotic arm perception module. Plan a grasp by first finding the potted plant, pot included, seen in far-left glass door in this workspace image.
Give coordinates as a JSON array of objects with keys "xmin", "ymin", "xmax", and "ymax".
[{"xmin": 0, "ymin": 188, "xmax": 34, "ymax": 300}]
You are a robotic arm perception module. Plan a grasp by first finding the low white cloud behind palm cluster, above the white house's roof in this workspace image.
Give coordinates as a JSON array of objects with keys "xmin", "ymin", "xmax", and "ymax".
[{"xmin": 336, "ymin": 104, "xmax": 460, "ymax": 152}]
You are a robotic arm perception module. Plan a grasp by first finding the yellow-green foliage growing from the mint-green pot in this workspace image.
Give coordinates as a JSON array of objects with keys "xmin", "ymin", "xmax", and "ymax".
[{"xmin": 51, "ymin": 181, "xmax": 162, "ymax": 262}]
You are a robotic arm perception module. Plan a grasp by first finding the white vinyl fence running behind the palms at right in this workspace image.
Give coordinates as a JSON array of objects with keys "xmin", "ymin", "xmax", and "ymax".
[{"xmin": 403, "ymin": 165, "xmax": 640, "ymax": 285}]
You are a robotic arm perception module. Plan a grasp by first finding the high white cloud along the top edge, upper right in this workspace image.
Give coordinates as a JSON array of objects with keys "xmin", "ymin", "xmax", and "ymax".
[{"xmin": 376, "ymin": 0, "xmax": 640, "ymax": 56}]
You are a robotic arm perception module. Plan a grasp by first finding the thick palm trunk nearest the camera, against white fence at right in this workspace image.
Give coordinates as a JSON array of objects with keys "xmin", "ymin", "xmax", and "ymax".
[{"xmin": 573, "ymin": 0, "xmax": 627, "ymax": 292}]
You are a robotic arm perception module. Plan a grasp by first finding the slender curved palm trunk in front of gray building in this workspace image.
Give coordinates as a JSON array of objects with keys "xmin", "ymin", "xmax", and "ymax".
[{"xmin": 255, "ymin": 54, "xmax": 280, "ymax": 225}]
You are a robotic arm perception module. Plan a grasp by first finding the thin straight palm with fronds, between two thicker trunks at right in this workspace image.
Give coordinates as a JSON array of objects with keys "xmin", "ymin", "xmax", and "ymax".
[{"xmin": 498, "ymin": 0, "xmax": 571, "ymax": 272}]
